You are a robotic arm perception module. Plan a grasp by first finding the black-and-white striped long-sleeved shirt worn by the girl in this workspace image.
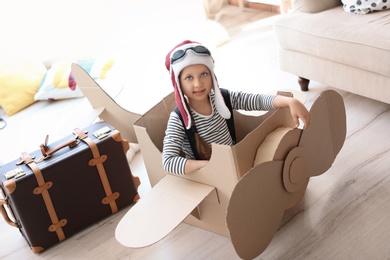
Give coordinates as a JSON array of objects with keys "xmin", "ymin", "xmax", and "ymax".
[{"xmin": 162, "ymin": 91, "xmax": 275, "ymax": 174}]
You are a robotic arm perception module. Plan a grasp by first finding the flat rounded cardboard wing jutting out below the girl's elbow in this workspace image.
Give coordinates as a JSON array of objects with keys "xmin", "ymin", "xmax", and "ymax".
[{"xmin": 115, "ymin": 175, "xmax": 218, "ymax": 248}]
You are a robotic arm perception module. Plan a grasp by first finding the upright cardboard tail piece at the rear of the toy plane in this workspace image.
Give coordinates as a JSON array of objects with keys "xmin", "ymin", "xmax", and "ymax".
[{"xmin": 71, "ymin": 63, "xmax": 141, "ymax": 143}]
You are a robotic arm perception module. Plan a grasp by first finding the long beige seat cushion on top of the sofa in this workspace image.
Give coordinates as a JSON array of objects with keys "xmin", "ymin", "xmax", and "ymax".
[{"xmin": 274, "ymin": 5, "xmax": 390, "ymax": 77}]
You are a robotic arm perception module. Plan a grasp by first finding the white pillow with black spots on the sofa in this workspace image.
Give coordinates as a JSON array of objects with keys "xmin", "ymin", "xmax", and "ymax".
[{"xmin": 342, "ymin": 0, "xmax": 390, "ymax": 14}]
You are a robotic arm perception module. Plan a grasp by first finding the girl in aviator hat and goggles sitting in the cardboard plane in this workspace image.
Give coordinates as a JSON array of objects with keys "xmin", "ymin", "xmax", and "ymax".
[{"xmin": 162, "ymin": 40, "xmax": 310, "ymax": 174}]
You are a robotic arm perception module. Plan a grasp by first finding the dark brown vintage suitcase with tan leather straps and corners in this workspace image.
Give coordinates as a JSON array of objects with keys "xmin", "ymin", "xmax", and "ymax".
[{"xmin": 0, "ymin": 122, "xmax": 140, "ymax": 253}]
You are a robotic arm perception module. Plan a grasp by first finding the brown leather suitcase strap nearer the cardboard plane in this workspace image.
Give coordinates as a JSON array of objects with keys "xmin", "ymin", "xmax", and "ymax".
[{"xmin": 74, "ymin": 128, "xmax": 119, "ymax": 214}]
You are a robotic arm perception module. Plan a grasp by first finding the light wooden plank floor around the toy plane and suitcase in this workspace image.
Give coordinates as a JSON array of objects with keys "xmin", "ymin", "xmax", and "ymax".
[{"xmin": 0, "ymin": 2, "xmax": 390, "ymax": 260}]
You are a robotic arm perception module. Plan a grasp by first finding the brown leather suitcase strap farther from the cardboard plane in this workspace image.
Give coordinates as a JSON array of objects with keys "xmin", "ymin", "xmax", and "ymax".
[{"xmin": 20, "ymin": 152, "xmax": 68, "ymax": 241}]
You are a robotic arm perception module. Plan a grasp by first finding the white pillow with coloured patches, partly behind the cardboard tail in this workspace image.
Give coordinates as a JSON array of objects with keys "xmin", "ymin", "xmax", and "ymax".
[{"xmin": 34, "ymin": 59, "xmax": 114, "ymax": 100}]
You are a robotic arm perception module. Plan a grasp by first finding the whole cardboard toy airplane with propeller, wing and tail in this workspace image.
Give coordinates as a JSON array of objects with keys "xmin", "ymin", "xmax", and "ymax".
[{"xmin": 72, "ymin": 64, "xmax": 346, "ymax": 259}]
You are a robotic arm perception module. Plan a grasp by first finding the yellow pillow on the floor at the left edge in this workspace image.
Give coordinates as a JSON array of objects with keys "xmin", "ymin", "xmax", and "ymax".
[{"xmin": 0, "ymin": 61, "xmax": 46, "ymax": 116}]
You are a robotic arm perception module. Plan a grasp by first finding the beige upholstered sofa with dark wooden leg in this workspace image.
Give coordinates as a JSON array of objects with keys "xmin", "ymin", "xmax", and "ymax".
[{"xmin": 274, "ymin": 0, "xmax": 390, "ymax": 103}]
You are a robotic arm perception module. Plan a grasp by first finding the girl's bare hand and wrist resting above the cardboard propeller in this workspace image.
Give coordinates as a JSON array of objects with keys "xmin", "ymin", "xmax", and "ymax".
[{"xmin": 272, "ymin": 96, "xmax": 310, "ymax": 129}]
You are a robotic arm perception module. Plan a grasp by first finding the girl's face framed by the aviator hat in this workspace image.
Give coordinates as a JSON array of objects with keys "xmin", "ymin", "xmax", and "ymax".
[{"xmin": 179, "ymin": 64, "xmax": 213, "ymax": 103}]
